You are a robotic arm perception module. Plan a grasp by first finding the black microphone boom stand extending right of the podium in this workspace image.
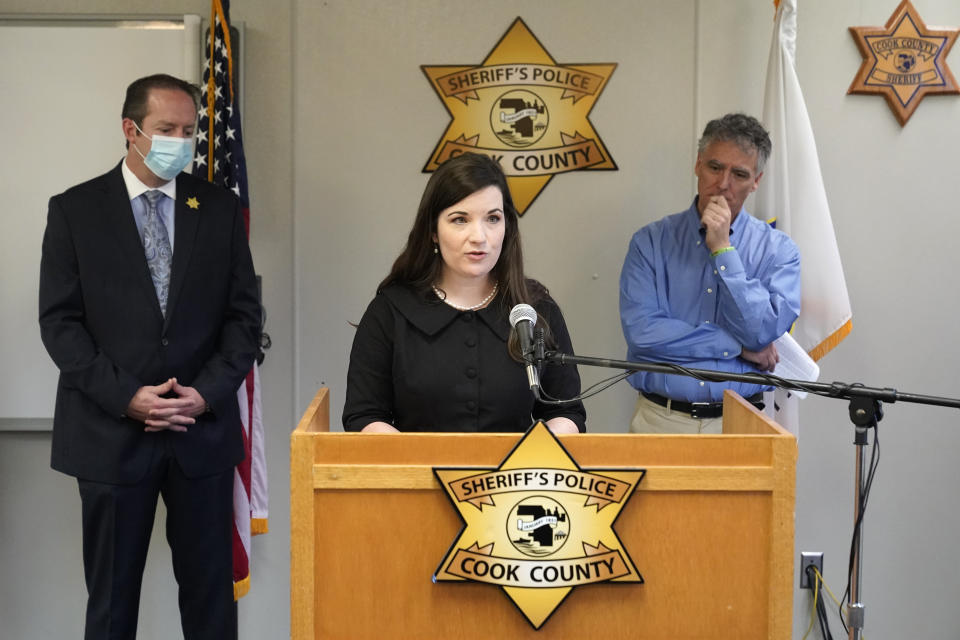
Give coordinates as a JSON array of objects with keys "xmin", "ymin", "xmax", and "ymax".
[{"xmin": 533, "ymin": 348, "xmax": 960, "ymax": 640}]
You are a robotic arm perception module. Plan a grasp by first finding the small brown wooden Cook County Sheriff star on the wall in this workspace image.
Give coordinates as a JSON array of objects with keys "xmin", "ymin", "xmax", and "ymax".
[{"xmin": 847, "ymin": 0, "xmax": 960, "ymax": 126}]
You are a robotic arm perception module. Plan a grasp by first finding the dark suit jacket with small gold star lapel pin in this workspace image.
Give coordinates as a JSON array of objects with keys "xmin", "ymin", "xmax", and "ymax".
[{"xmin": 40, "ymin": 165, "xmax": 260, "ymax": 484}]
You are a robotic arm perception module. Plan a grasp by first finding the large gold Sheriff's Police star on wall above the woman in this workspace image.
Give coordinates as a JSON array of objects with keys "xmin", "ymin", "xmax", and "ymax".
[{"xmin": 421, "ymin": 18, "xmax": 617, "ymax": 215}]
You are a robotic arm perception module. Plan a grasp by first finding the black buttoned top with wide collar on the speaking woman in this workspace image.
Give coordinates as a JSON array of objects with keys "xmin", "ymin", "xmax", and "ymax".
[{"xmin": 343, "ymin": 285, "xmax": 586, "ymax": 432}]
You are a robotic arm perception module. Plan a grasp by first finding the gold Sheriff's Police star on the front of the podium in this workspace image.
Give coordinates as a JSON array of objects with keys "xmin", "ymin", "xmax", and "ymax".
[{"xmin": 433, "ymin": 422, "xmax": 645, "ymax": 629}]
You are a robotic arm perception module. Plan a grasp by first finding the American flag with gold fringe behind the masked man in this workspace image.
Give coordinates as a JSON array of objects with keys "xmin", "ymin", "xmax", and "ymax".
[{"xmin": 193, "ymin": 0, "xmax": 267, "ymax": 599}]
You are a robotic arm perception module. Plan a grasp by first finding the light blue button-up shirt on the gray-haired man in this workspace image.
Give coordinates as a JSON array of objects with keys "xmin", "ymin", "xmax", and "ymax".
[{"xmin": 620, "ymin": 198, "xmax": 800, "ymax": 402}]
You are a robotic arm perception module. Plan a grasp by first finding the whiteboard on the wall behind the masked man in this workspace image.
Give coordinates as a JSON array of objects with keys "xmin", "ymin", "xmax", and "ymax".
[{"xmin": 0, "ymin": 15, "xmax": 202, "ymax": 429}]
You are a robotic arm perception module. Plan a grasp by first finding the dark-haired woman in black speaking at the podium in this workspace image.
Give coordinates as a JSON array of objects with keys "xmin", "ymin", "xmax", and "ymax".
[{"xmin": 343, "ymin": 153, "xmax": 586, "ymax": 433}]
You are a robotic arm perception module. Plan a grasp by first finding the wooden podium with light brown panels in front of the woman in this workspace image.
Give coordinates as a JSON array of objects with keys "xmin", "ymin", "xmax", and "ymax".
[{"xmin": 290, "ymin": 389, "xmax": 797, "ymax": 640}]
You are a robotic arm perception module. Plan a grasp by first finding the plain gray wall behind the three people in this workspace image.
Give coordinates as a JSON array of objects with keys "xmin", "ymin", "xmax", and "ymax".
[{"xmin": 0, "ymin": 0, "xmax": 960, "ymax": 640}]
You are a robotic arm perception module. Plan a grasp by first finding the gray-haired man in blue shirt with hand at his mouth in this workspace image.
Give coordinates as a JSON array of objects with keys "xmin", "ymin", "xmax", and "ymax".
[{"xmin": 620, "ymin": 114, "xmax": 800, "ymax": 433}]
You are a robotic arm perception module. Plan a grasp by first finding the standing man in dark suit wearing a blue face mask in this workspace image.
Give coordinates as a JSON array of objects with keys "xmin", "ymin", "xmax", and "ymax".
[{"xmin": 39, "ymin": 75, "xmax": 260, "ymax": 640}]
